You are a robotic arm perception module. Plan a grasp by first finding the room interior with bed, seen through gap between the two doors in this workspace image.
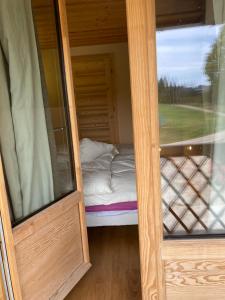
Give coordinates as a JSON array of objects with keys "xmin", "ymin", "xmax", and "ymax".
[{"xmin": 63, "ymin": 1, "xmax": 141, "ymax": 299}]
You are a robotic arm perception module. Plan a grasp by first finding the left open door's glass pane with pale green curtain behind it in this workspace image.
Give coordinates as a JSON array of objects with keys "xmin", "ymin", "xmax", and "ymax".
[{"xmin": 0, "ymin": 0, "xmax": 76, "ymax": 225}]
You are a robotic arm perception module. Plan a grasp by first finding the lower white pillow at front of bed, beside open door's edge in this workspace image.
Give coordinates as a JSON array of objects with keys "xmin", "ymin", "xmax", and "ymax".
[{"xmin": 83, "ymin": 170, "xmax": 112, "ymax": 196}]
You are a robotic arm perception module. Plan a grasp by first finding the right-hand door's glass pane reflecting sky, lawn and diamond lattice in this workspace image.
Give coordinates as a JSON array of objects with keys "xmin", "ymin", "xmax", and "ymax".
[{"xmin": 156, "ymin": 0, "xmax": 225, "ymax": 237}]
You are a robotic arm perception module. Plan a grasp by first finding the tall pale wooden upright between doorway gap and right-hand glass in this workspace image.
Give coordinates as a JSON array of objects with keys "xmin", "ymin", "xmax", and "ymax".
[{"xmin": 127, "ymin": 0, "xmax": 164, "ymax": 300}]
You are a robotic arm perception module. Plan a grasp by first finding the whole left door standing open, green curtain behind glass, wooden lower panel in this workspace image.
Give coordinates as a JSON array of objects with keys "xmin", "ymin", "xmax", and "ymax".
[{"xmin": 0, "ymin": 0, "xmax": 90, "ymax": 299}]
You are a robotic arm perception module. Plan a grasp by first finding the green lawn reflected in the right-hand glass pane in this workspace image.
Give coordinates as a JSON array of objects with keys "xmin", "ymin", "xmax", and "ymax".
[{"xmin": 159, "ymin": 104, "xmax": 225, "ymax": 144}]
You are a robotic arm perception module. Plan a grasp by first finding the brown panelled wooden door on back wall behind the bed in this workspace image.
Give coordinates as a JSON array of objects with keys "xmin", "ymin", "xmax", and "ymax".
[{"xmin": 72, "ymin": 54, "xmax": 117, "ymax": 143}]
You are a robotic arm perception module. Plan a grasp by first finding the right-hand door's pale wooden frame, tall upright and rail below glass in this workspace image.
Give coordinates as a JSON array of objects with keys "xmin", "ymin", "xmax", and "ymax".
[{"xmin": 126, "ymin": 0, "xmax": 225, "ymax": 300}]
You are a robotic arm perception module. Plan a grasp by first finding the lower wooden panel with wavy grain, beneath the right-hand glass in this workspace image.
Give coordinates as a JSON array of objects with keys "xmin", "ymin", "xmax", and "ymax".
[{"xmin": 165, "ymin": 259, "xmax": 225, "ymax": 300}]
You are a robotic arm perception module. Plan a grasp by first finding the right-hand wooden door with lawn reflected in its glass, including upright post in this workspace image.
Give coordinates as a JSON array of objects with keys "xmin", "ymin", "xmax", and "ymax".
[{"xmin": 126, "ymin": 0, "xmax": 225, "ymax": 300}]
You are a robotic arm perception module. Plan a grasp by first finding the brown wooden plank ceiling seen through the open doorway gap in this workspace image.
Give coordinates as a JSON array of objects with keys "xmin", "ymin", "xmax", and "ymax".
[{"xmin": 67, "ymin": 0, "xmax": 127, "ymax": 47}]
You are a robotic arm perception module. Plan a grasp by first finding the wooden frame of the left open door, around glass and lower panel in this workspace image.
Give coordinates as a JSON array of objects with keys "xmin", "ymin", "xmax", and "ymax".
[{"xmin": 0, "ymin": 0, "xmax": 91, "ymax": 300}]
